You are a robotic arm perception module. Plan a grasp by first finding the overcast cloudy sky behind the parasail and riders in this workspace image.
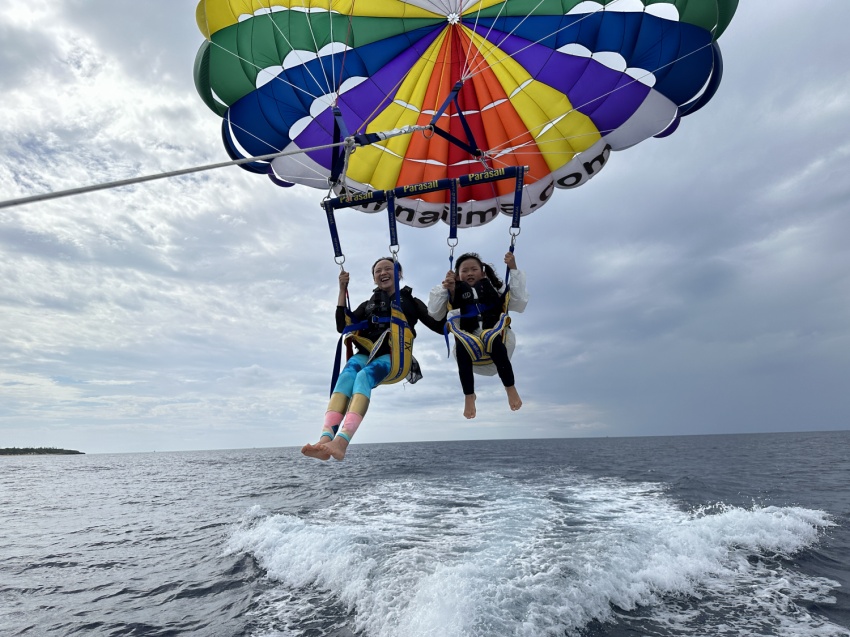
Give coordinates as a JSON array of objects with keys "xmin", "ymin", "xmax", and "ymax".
[{"xmin": 0, "ymin": 0, "xmax": 850, "ymax": 453}]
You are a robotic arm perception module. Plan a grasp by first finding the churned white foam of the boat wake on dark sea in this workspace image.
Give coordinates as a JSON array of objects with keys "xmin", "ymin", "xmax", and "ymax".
[{"xmin": 228, "ymin": 473, "xmax": 850, "ymax": 637}]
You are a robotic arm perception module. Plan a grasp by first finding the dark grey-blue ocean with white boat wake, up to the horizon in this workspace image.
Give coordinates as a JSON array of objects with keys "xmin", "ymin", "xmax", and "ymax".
[{"xmin": 0, "ymin": 431, "xmax": 850, "ymax": 637}]
